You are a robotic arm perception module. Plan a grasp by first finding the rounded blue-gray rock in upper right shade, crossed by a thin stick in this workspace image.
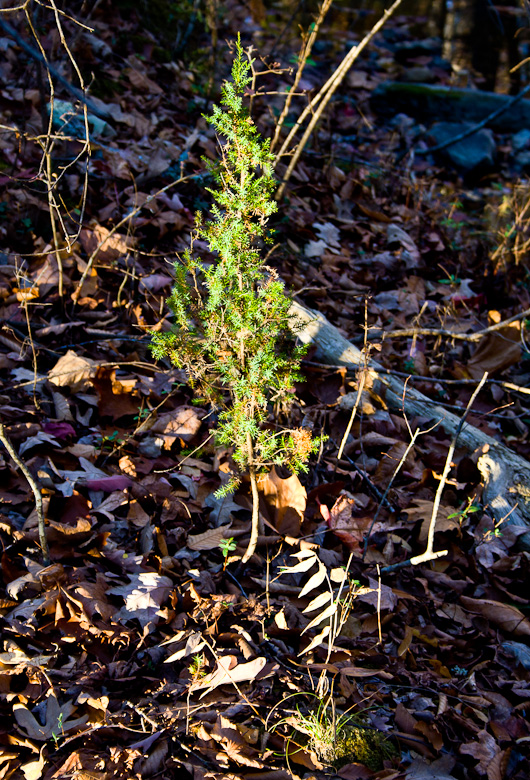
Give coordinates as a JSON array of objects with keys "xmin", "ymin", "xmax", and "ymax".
[{"xmin": 427, "ymin": 122, "xmax": 496, "ymax": 174}]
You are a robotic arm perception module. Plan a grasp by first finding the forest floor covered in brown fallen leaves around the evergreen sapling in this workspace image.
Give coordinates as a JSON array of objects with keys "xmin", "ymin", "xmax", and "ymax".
[{"xmin": 0, "ymin": 2, "xmax": 530, "ymax": 780}]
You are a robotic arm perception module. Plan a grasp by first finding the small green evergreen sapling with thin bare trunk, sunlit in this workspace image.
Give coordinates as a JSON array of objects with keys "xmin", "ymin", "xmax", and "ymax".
[{"xmin": 151, "ymin": 38, "xmax": 315, "ymax": 561}]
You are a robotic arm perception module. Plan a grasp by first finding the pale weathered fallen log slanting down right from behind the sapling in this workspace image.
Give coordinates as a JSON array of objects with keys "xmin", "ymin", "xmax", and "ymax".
[{"xmin": 291, "ymin": 301, "xmax": 530, "ymax": 551}]
